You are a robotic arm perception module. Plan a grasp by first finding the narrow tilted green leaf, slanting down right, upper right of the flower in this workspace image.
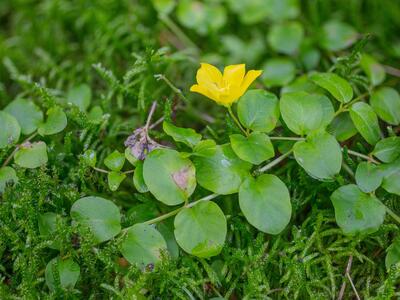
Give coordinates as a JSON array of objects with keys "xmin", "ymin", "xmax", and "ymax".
[{"xmin": 310, "ymin": 73, "xmax": 353, "ymax": 103}]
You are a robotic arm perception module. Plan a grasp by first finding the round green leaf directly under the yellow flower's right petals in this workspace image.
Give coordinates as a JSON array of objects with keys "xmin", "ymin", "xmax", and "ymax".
[{"xmin": 237, "ymin": 90, "xmax": 279, "ymax": 132}]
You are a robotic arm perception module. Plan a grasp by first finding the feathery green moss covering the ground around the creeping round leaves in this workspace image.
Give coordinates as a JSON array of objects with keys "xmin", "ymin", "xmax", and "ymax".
[{"xmin": 0, "ymin": 0, "xmax": 400, "ymax": 299}]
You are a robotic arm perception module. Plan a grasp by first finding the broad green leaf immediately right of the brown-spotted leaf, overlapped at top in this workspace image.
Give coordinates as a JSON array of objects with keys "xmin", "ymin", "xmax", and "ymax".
[{"xmin": 193, "ymin": 145, "xmax": 252, "ymax": 195}]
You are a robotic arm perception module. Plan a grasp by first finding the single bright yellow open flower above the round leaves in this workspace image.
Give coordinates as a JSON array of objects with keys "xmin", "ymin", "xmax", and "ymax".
[{"xmin": 190, "ymin": 63, "xmax": 262, "ymax": 106}]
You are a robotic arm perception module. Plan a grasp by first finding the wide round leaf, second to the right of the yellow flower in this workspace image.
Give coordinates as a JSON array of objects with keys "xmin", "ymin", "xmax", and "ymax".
[{"xmin": 280, "ymin": 92, "xmax": 334, "ymax": 135}]
